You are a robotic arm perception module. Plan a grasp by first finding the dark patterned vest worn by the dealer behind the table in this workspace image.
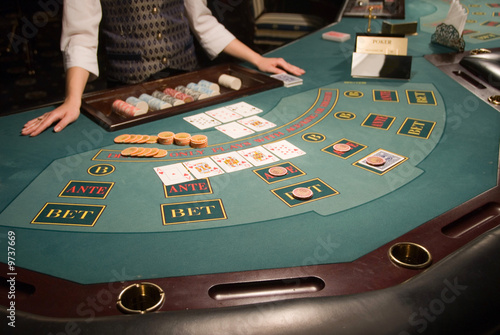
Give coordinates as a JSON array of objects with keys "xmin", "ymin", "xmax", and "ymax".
[{"xmin": 98, "ymin": 0, "xmax": 197, "ymax": 83}]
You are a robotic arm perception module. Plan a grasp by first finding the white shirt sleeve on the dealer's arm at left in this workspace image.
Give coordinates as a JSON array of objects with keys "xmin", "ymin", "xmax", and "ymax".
[{"xmin": 61, "ymin": 0, "xmax": 102, "ymax": 79}]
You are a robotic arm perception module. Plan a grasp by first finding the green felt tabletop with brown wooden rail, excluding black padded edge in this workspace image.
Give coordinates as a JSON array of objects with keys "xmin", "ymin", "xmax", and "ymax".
[{"xmin": 0, "ymin": 1, "xmax": 500, "ymax": 334}]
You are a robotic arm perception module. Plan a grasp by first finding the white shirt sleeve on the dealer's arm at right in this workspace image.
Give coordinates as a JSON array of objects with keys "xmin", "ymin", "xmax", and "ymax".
[{"xmin": 184, "ymin": 0, "xmax": 235, "ymax": 59}]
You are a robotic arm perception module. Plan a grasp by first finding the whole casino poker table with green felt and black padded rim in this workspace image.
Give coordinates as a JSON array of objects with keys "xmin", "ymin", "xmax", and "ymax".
[{"xmin": 0, "ymin": 0, "xmax": 500, "ymax": 334}]
